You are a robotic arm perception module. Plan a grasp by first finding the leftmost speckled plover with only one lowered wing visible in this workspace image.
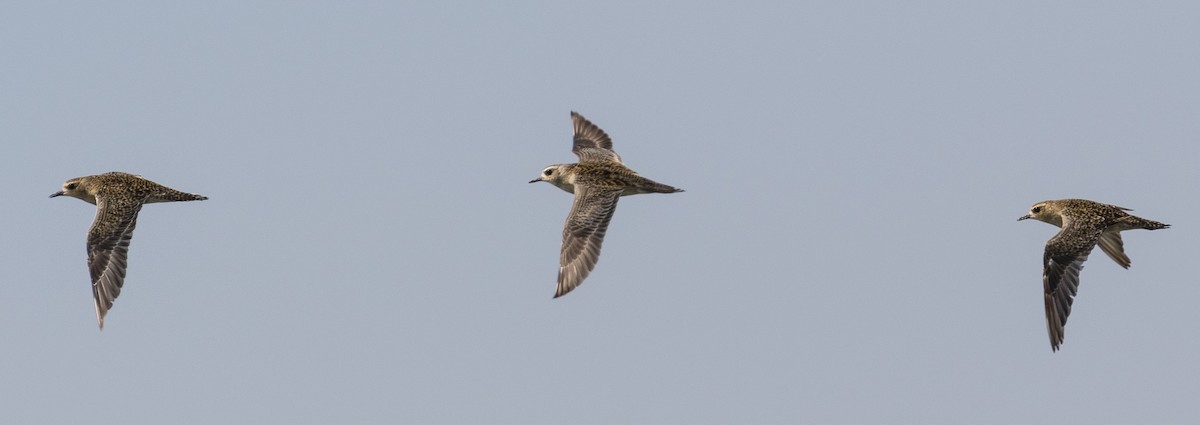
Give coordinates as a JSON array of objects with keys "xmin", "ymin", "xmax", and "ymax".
[{"xmin": 50, "ymin": 172, "xmax": 208, "ymax": 329}]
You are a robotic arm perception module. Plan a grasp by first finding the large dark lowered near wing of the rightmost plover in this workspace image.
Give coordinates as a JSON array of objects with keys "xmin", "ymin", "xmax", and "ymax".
[{"xmin": 1042, "ymin": 226, "xmax": 1100, "ymax": 351}]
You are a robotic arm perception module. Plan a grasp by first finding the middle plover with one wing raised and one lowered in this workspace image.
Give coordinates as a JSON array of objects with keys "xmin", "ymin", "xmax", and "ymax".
[{"xmin": 529, "ymin": 112, "xmax": 683, "ymax": 298}]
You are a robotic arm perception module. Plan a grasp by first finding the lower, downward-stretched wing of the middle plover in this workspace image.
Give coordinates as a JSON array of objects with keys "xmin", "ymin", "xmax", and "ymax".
[{"xmin": 554, "ymin": 185, "xmax": 622, "ymax": 298}]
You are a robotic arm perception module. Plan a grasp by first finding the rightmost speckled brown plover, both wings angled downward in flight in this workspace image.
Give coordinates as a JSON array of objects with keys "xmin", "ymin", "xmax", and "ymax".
[{"xmin": 1016, "ymin": 199, "xmax": 1170, "ymax": 351}]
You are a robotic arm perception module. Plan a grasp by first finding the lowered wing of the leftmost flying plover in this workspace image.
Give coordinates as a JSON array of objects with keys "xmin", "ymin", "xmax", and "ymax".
[{"xmin": 88, "ymin": 197, "xmax": 142, "ymax": 329}]
